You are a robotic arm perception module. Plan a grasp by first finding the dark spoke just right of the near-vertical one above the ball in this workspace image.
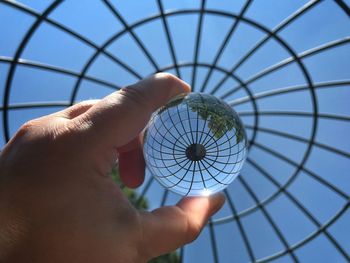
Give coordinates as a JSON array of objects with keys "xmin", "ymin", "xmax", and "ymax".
[{"xmin": 200, "ymin": 0, "xmax": 252, "ymax": 92}]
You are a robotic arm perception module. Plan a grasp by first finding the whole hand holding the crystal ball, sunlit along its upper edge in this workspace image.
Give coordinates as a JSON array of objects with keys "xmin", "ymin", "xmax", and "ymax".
[{"xmin": 0, "ymin": 73, "xmax": 224, "ymax": 263}]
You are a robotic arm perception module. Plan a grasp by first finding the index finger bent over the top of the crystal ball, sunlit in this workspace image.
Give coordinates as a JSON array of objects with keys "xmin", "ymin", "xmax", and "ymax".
[{"xmin": 76, "ymin": 73, "xmax": 190, "ymax": 151}]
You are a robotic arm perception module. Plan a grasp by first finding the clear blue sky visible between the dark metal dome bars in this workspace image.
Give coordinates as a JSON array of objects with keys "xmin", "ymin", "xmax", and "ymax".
[{"xmin": 0, "ymin": 0, "xmax": 350, "ymax": 262}]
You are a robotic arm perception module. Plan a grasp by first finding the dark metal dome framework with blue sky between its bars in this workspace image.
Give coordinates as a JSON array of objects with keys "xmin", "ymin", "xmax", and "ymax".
[{"xmin": 0, "ymin": 0, "xmax": 350, "ymax": 262}]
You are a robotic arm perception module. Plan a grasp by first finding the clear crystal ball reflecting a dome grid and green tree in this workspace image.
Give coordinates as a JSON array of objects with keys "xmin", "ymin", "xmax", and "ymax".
[{"xmin": 143, "ymin": 92, "xmax": 248, "ymax": 196}]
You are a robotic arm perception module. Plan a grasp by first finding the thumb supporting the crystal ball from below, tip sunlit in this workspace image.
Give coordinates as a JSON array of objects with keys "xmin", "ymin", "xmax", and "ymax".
[{"xmin": 141, "ymin": 193, "xmax": 225, "ymax": 257}]
